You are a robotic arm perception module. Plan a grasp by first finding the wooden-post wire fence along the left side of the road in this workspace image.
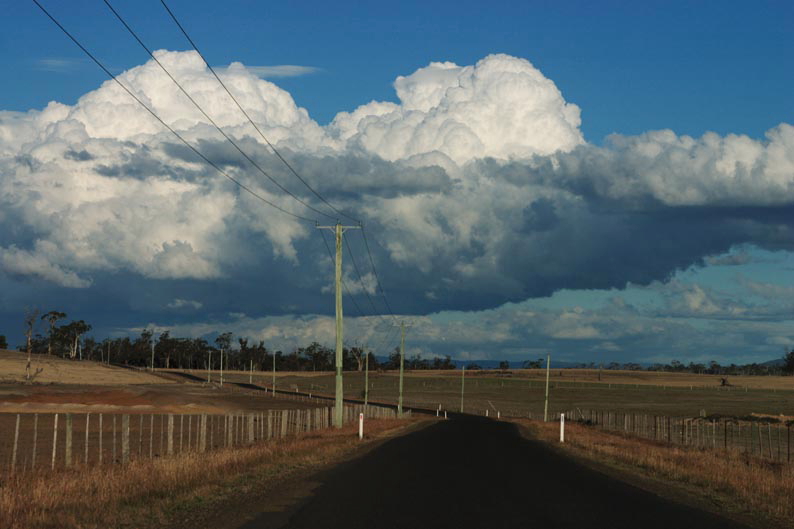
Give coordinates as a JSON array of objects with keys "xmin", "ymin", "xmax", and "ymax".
[{"xmin": 0, "ymin": 405, "xmax": 397, "ymax": 475}]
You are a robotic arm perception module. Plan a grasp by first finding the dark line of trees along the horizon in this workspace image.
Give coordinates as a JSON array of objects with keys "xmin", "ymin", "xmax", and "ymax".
[{"xmin": 7, "ymin": 310, "xmax": 794, "ymax": 376}]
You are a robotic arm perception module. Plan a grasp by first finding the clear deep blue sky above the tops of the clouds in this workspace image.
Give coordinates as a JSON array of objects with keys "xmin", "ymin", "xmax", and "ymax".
[{"xmin": 0, "ymin": 0, "xmax": 794, "ymax": 142}]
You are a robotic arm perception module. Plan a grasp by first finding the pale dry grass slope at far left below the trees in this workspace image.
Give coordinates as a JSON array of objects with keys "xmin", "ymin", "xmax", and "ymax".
[{"xmin": 0, "ymin": 350, "xmax": 171, "ymax": 386}]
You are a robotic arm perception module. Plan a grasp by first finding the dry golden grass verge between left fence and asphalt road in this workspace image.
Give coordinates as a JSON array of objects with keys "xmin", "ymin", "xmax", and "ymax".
[{"xmin": 0, "ymin": 420, "xmax": 418, "ymax": 529}]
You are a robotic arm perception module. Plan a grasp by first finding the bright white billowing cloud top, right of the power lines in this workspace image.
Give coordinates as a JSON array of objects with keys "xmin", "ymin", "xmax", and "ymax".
[{"xmin": 329, "ymin": 55, "xmax": 584, "ymax": 163}]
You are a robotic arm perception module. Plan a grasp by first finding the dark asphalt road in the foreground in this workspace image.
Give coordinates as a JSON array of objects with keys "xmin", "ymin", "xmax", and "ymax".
[{"xmin": 244, "ymin": 417, "xmax": 746, "ymax": 529}]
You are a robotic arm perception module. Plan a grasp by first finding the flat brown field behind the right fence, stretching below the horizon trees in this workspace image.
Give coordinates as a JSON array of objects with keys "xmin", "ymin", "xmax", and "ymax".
[{"xmin": 224, "ymin": 370, "xmax": 794, "ymax": 417}]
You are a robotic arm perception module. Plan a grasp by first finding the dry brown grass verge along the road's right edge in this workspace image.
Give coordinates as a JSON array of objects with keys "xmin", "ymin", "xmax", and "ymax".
[{"xmin": 516, "ymin": 420, "xmax": 794, "ymax": 528}]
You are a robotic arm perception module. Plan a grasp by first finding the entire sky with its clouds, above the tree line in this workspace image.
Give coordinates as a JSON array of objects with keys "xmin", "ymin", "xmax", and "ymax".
[{"xmin": 0, "ymin": 0, "xmax": 794, "ymax": 362}]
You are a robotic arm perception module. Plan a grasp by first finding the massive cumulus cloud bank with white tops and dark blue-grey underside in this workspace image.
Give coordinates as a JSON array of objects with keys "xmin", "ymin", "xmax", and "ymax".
[{"xmin": 0, "ymin": 51, "xmax": 794, "ymax": 346}]
